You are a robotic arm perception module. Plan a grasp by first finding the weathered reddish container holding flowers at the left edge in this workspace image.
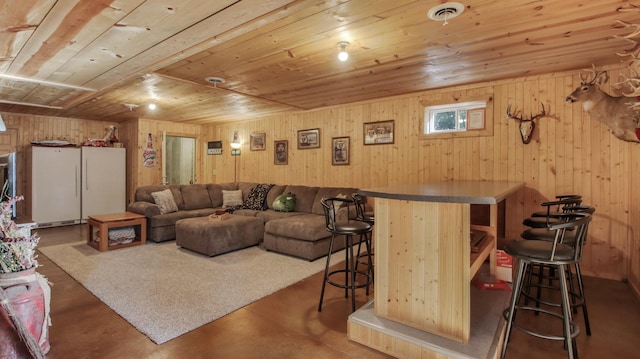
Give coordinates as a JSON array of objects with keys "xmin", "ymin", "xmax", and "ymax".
[{"xmin": 0, "ymin": 268, "xmax": 50, "ymax": 359}]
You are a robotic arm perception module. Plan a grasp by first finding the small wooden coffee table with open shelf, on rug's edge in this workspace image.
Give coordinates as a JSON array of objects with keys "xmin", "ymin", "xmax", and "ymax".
[{"xmin": 87, "ymin": 212, "xmax": 147, "ymax": 252}]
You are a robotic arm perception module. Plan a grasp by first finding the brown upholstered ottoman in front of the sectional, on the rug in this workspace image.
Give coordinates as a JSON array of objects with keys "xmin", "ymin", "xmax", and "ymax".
[{"xmin": 176, "ymin": 215, "xmax": 264, "ymax": 257}]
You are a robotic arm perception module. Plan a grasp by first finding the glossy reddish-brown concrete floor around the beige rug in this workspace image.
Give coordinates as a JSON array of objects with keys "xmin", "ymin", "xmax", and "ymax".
[{"xmin": 36, "ymin": 225, "xmax": 640, "ymax": 359}]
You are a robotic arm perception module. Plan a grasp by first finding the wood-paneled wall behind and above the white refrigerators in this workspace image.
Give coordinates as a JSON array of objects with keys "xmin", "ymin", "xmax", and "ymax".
[{"xmin": 0, "ymin": 112, "xmax": 119, "ymax": 216}]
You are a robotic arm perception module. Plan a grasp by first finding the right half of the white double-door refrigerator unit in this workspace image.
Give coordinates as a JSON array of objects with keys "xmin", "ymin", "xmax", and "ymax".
[{"xmin": 82, "ymin": 147, "xmax": 127, "ymax": 222}]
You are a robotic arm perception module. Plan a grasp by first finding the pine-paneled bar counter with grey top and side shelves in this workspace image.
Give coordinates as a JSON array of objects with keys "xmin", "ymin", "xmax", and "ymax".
[{"xmin": 349, "ymin": 181, "xmax": 524, "ymax": 358}]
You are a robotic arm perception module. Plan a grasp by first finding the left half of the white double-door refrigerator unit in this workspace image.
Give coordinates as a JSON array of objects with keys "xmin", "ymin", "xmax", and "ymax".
[{"xmin": 30, "ymin": 146, "xmax": 82, "ymax": 227}]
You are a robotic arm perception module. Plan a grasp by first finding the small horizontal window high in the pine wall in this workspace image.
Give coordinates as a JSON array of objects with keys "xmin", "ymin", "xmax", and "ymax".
[{"xmin": 422, "ymin": 101, "xmax": 487, "ymax": 134}]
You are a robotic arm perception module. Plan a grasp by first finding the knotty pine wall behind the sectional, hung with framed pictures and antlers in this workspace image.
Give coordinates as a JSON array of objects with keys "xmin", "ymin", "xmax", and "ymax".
[{"xmin": 203, "ymin": 65, "xmax": 640, "ymax": 293}]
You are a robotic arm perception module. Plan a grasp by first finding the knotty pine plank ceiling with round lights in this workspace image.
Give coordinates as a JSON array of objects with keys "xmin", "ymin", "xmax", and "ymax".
[{"xmin": 0, "ymin": 0, "xmax": 640, "ymax": 124}]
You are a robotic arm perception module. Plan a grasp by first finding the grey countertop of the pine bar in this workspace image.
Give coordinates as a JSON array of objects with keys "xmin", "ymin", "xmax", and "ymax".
[{"xmin": 358, "ymin": 181, "xmax": 524, "ymax": 204}]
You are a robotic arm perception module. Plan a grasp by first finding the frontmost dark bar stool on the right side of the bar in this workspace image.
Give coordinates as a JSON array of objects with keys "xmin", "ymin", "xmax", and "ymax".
[{"xmin": 501, "ymin": 213, "xmax": 591, "ymax": 359}]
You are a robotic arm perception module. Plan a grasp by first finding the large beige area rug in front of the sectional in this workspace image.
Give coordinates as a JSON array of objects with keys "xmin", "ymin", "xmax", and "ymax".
[{"xmin": 40, "ymin": 242, "xmax": 344, "ymax": 344}]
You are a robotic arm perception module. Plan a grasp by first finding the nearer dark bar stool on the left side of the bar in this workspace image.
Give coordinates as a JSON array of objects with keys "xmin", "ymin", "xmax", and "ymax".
[{"xmin": 318, "ymin": 198, "xmax": 372, "ymax": 312}]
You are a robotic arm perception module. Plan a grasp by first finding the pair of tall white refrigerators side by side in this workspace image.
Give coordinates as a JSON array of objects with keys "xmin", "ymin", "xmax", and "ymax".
[{"xmin": 27, "ymin": 146, "xmax": 126, "ymax": 228}]
